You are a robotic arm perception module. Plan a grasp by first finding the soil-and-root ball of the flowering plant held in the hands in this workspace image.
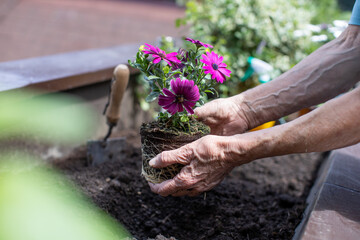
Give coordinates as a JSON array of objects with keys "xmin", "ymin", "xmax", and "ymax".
[{"xmin": 140, "ymin": 119, "xmax": 210, "ymax": 183}]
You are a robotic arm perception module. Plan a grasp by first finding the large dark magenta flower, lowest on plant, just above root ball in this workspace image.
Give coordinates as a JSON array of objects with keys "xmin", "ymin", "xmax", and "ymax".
[{"xmin": 158, "ymin": 78, "xmax": 200, "ymax": 115}]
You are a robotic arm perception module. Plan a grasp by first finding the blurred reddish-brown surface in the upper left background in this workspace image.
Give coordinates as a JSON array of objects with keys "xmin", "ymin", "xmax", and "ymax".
[{"xmin": 0, "ymin": 0, "xmax": 184, "ymax": 62}]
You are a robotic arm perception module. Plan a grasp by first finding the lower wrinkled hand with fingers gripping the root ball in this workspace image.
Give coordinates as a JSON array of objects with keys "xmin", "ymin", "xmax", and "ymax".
[{"xmin": 149, "ymin": 135, "xmax": 243, "ymax": 196}]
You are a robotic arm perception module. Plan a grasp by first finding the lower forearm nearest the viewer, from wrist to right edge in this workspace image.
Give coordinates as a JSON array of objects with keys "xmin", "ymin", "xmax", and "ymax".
[{"xmin": 230, "ymin": 88, "xmax": 360, "ymax": 164}]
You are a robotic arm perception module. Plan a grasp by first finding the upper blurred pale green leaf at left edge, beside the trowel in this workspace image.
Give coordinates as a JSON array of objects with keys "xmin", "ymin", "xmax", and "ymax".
[{"xmin": 0, "ymin": 92, "xmax": 95, "ymax": 143}]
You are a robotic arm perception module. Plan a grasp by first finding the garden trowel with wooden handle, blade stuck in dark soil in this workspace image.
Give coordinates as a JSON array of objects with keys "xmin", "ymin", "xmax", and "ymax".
[{"xmin": 87, "ymin": 64, "xmax": 130, "ymax": 165}]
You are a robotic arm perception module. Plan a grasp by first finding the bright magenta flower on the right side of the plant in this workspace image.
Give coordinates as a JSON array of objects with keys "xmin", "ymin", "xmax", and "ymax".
[{"xmin": 200, "ymin": 52, "xmax": 231, "ymax": 83}]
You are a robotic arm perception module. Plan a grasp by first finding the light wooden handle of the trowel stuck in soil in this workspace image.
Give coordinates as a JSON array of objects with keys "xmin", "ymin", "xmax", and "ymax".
[{"xmin": 106, "ymin": 64, "xmax": 130, "ymax": 126}]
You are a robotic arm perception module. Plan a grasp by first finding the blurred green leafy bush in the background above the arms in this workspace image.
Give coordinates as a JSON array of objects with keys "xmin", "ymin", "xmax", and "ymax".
[{"xmin": 176, "ymin": 0, "xmax": 352, "ymax": 97}]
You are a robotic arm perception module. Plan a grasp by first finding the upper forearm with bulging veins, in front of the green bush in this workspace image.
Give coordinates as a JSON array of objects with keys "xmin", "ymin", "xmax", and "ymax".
[{"xmin": 233, "ymin": 25, "xmax": 360, "ymax": 129}]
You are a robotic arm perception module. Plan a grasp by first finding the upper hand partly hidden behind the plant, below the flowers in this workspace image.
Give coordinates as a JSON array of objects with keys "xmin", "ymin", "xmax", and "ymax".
[{"xmin": 195, "ymin": 98, "xmax": 249, "ymax": 136}]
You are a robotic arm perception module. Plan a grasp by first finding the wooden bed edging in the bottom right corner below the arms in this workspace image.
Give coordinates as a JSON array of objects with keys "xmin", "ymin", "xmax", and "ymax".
[{"xmin": 293, "ymin": 144, "xmax": 360, "ymax": 240}]
